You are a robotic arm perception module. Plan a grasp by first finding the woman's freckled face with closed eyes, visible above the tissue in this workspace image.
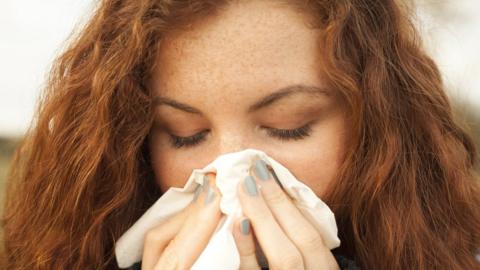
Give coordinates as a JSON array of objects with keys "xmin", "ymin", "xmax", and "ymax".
[{"xmin": 149, "ymin": 1, "xmax": 348, "ymax": 197}]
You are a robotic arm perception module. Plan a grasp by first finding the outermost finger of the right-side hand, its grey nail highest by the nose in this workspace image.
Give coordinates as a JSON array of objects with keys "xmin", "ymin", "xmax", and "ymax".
[{"xmin": 251, "ymin": 159, "xmax": 335, "ymax": 269}]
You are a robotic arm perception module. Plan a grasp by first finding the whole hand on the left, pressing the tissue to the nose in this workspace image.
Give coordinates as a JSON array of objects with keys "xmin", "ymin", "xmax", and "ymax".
[{"xmin": 142, "ymin": 173, "xmax": 222, "ymax": 270}]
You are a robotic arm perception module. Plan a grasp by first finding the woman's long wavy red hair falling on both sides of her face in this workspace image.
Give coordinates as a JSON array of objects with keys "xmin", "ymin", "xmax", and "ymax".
[{"xmin": 2, "ymin": 0, "xmax": 480, "ymax": 270}]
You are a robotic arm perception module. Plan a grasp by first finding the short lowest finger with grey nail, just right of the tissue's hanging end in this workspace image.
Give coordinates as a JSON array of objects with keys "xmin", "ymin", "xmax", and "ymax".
[{"xmin": 233, "ymin": 217, "xmax": 260, "ymax": 270}]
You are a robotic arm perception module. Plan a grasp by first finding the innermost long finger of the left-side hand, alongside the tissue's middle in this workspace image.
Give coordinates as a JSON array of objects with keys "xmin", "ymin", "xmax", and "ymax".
[{"xmin": 155, "ymin": 174, "xmax": 221, "ymax": 269}]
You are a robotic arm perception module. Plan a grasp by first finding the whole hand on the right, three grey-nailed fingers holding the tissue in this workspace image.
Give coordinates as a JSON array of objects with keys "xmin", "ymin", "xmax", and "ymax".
[{"xmin": 233, "ymin": 160, "xmax": 339, "ymax": 270}]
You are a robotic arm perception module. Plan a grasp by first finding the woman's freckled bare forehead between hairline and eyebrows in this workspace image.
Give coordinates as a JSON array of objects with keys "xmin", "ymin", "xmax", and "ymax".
[{"xmin": 153, "ymin": 1, "xmax": 319, "ymax": 100}]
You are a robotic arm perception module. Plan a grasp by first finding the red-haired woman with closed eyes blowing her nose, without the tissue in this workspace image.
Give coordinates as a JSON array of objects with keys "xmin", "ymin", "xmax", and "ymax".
[{"xmin": 0, "ymin": 0, "xmax": 480, "ymax": 269}]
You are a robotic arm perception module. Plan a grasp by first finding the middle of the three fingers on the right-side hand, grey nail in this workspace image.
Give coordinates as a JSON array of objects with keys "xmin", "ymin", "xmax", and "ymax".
[{"xmin": 237, "ymin": 176, "xmax": 304, "ymax": 269}]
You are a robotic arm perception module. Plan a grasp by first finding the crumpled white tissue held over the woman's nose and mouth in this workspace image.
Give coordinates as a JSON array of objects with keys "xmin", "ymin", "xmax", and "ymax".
[{"xmin": 115, "ymin": 149, "xmax": 340, "ymax": 270}]
